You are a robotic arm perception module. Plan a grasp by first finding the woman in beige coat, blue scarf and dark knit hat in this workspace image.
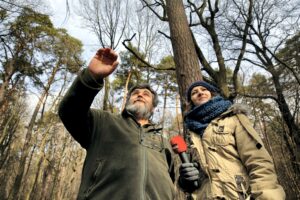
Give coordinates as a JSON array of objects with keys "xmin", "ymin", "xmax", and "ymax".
[{"xmin": 179, "ymin": 81, "xmax": 285, "ymax": 200}]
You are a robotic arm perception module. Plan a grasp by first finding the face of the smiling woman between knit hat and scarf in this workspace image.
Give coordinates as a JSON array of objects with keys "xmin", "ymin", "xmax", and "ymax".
[{"xmin": 191, "ymin": 86, "xmax": 212, "ymax": 106}]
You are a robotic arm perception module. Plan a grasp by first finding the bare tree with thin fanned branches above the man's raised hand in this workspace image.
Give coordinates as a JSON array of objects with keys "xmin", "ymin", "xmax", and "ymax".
[{"xmin": 77, "ymin": 0, "xmax": 129, "ymax": 110}]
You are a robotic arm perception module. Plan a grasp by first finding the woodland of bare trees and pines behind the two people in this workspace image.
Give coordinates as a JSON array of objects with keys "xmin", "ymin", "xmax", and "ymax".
[{"xmin": 0, "ymin": 0, "xmax": 300, "ymax": 200}]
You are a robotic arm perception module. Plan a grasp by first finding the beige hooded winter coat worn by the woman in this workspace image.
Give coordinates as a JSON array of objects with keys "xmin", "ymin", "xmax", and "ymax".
[{"xmin": 191, "ymin": 105, "xmax": 285, "ymax": 200}]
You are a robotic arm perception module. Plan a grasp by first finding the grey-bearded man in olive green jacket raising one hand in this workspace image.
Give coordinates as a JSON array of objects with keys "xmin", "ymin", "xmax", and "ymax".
[{"xmin": 59, "ymin": 48, "xmax": 175, "ymax": 200}]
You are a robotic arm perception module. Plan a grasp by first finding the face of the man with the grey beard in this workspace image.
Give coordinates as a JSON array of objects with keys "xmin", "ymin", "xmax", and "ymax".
[{"xmin": 126, "ymin": 89, "xmax": 154, "ymax": 119}]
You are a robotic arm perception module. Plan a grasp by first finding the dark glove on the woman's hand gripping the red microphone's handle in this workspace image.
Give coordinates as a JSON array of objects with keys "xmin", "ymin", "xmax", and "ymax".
[{"xmin": 179, "ymin": 163, "xmax": 200, "ymax": 192}]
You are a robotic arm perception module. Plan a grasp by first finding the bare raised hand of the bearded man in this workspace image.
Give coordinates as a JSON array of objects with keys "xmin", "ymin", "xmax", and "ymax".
[{"xmin": 88, "ymin": 48, "xmax": 119, "ymax": 79}]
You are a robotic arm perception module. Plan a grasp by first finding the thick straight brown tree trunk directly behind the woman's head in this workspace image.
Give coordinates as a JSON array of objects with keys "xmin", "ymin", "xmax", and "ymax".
[{"xmin": 166, "ymin": 0, "xmax": 202, "ymax": 111}]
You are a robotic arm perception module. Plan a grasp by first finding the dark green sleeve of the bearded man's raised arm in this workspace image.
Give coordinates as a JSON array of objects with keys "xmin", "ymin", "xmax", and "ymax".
[{"xmin": 58, "ymin": 69, "xmax": 103, "ymax": 148}]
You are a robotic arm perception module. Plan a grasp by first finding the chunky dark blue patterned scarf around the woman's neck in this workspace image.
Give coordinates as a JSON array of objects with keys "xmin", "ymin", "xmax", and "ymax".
[{"xmin": 185, "ymin": 96, "xmax": 232, "ymax": 137}]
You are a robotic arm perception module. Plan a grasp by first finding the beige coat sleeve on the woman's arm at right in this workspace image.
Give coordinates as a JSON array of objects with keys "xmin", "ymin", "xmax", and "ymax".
[{"xmin": 236, "ymin": 114, "xmax": 285, "ymax": 200}]
